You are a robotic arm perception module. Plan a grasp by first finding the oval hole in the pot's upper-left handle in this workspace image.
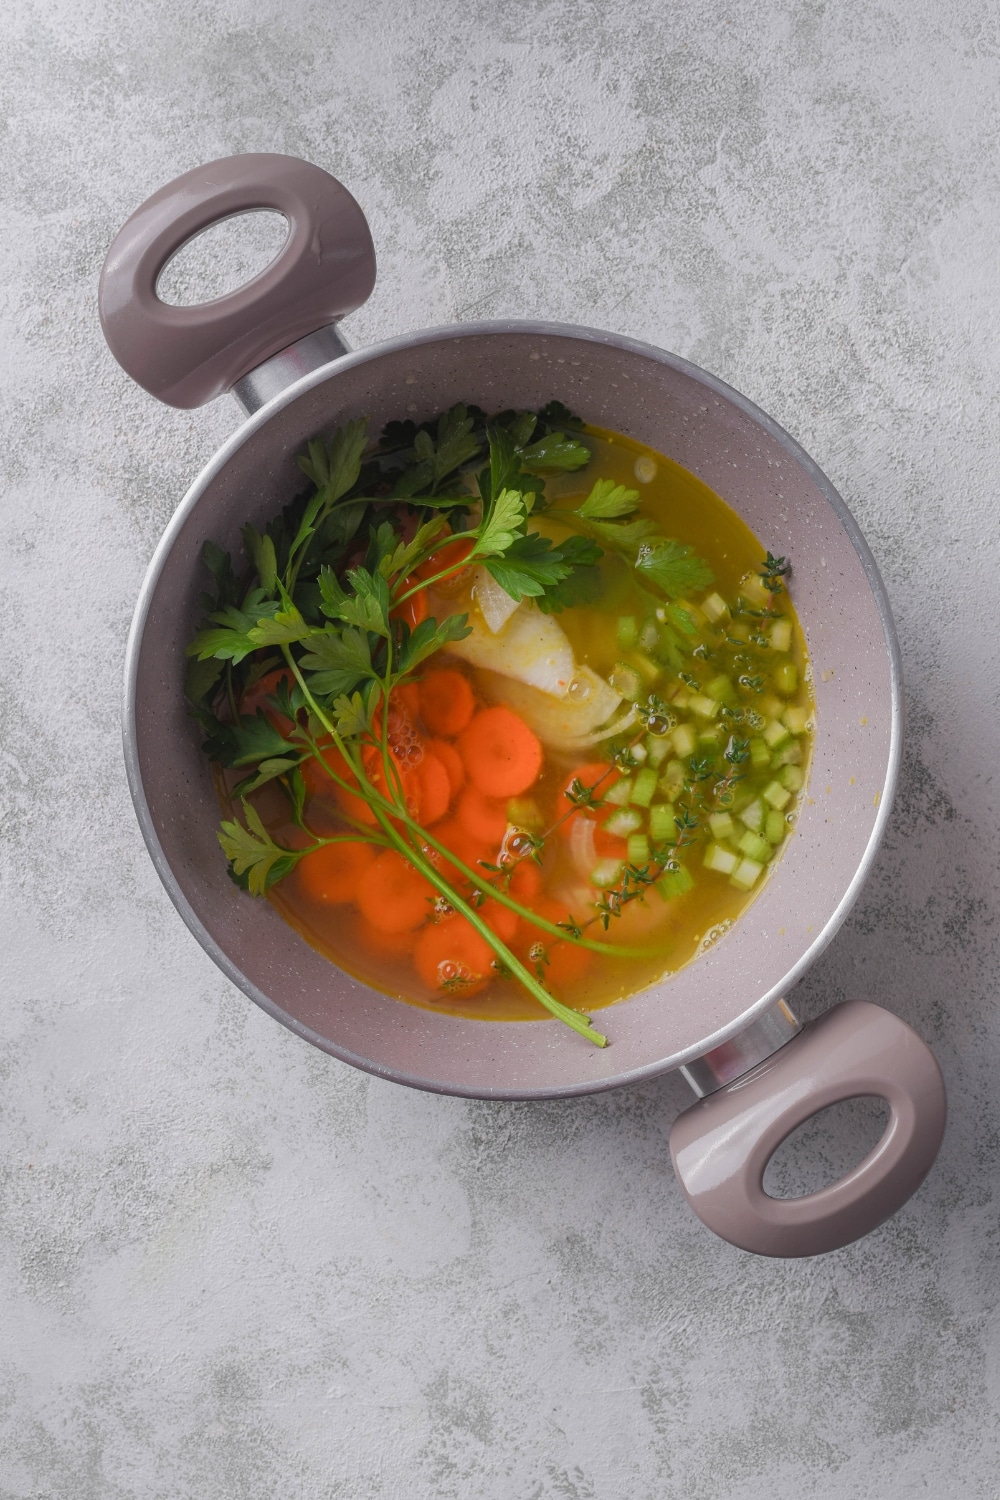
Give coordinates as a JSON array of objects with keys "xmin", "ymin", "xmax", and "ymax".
[{"xmin": 156, "ymin": 209, "xmax": 288, "ymax": 308}]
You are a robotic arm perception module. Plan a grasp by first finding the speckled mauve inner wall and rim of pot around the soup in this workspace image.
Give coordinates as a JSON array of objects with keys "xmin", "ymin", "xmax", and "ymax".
[{"xmin": 126, "ymin": 324, "xmax": 900, "ymax": 1098}]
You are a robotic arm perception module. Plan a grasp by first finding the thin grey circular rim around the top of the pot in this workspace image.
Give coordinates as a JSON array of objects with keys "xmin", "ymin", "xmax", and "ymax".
[{"xmin": 121, "ymin": 318, "xmax": 903, "ymax": 1101}]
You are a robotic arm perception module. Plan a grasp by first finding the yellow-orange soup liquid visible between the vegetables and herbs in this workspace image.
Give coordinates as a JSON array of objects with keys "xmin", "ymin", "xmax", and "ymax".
[{"xmin": 258, "ymin": 428, "xmax": 813, "ymax": 1020}]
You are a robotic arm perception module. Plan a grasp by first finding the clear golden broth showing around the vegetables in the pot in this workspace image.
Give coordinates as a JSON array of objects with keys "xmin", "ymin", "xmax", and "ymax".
[{"xmin": 258, "ymin": 428, "xmax": 813, "ymax": 1020}]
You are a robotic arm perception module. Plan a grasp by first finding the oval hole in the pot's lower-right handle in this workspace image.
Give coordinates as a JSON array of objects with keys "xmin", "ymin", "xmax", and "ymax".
[{"xmin": 763, "ymin": 1095, "xmax": 889, "ymax": 1199}]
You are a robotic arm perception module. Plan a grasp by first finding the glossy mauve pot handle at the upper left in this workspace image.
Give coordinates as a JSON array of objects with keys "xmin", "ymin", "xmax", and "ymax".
[{"xmin": 99, "ymin": 153, "xmax": 375, "ymax": 407}]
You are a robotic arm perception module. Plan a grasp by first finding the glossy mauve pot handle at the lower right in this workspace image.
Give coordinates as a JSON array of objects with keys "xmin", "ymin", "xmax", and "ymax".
[{"xmin": 670, "ymin": 1001, "xmax": 946, "ymax": 1256}]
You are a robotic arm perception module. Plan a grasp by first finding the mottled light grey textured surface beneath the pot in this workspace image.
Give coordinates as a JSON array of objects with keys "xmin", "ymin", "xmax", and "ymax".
[{"xmin": 0, "ymin": 0, "xmax": 1000, "ymax": 1500}]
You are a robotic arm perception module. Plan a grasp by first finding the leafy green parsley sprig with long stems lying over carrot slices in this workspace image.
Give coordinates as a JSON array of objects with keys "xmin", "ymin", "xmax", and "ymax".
[{"xmin": 186, "ymin": 402, "xmax": 711, "ymax": 1046}]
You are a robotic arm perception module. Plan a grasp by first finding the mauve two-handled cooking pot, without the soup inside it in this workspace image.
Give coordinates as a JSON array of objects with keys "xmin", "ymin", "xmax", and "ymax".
[{"xmin": 100, "ymin": 155, "xmax": 945, "ymax": 1256}]
